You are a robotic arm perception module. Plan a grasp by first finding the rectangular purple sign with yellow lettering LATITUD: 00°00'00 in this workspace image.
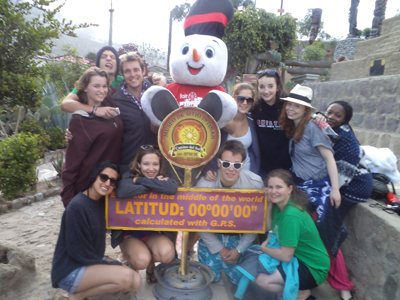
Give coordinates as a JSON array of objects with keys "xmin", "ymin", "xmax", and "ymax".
[{"xmin": 106, "ymin": 188, "xmax": 267, "ymax": 233}]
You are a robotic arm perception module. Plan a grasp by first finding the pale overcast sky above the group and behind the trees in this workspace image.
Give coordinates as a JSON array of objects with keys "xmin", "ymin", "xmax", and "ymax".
[{"xmin": 57, "ymin": 0, "xmax": 400, "ymax": 50}]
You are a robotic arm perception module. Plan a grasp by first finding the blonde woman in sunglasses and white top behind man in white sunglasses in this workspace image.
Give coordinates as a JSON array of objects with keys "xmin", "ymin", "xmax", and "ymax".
[{"xmin": 205, "ymin": 83, "xmax": 260, "ymax": 181}]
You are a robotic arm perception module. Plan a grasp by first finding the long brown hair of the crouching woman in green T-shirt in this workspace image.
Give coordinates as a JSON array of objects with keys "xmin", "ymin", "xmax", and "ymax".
[{"xmin": 265, "ymin": 169, "xmax": 309, "ymax": 212}]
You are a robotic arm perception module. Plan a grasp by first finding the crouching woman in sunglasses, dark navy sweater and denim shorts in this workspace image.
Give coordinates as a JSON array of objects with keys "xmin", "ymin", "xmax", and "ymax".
[{"xmin": 51, "ymin": 161, "xmax": 142, "ymax": 300}]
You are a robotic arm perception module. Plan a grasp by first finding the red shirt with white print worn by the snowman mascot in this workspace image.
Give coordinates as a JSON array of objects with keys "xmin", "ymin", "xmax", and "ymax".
[{"xmin": 166, "ymin": 82, "xmax": 226, "ymax": 107}]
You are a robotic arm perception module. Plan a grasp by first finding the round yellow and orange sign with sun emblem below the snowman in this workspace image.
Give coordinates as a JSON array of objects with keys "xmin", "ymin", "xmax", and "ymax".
[{"xmin": 158, "ymin": 107, "xmax": 220, "ymax": 168}]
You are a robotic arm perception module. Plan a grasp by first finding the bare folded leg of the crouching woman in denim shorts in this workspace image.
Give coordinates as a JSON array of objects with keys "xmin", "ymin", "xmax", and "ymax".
[{"xmin": 68, "ymin": 265, "xmax": 142, "ymax": 300}]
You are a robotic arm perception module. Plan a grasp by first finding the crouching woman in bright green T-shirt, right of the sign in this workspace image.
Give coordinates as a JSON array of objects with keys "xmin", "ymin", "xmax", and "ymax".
[{"xmin": 255, "ymin": 169, "xmax": 329, "ymax": 300}]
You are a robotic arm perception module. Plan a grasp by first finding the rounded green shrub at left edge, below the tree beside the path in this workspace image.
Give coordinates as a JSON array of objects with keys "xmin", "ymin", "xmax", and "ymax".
[{"xmin": 0, "ymin": 133, "xmax": 39, "ymax": 199}]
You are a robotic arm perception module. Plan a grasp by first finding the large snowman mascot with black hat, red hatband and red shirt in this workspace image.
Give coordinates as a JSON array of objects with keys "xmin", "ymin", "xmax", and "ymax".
[{"xmin": 142, "ymin": 0, "xmax": 237, "ymax": 128}]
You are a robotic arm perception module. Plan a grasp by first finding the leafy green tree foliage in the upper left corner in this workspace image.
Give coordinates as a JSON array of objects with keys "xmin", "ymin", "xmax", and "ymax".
[{"xmin": 0, "ymin": 0, "xmax": 92, "ymax": 108}]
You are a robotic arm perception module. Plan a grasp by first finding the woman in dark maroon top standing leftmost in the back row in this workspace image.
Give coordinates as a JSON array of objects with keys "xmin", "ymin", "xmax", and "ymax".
[{"xmin": 60, "ymin": 67, "xmax": 123, "ymax": 207}]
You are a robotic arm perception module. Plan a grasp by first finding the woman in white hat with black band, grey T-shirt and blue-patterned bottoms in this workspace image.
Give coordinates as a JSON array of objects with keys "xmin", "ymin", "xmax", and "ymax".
[{"xmin": 279, "ymin": 85, "xmax": 347, "ymax": 255}]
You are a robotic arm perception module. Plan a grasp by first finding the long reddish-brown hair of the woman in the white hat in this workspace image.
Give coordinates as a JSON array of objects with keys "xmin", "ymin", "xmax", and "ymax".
[{"xmin": 278, "ymin": 101, "xmax": 312, "ymax": 143}]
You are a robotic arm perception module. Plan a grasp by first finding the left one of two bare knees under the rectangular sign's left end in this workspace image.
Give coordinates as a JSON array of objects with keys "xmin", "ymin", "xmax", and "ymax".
[{"xmin": 121, "ymin": 236, "xmax": 151, "ymax": 270}]
